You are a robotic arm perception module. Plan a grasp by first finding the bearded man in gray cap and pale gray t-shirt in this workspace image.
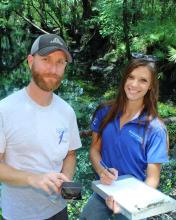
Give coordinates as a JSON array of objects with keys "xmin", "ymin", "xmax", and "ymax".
[{"xmin": 0, "ymin": 34, "xmax": 81, "ymax": 220}]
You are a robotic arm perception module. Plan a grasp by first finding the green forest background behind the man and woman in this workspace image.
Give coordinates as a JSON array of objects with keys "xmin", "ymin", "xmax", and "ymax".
[{"xmin": 0, "ymin": 0, "xmax": 176, "ymax": 220}]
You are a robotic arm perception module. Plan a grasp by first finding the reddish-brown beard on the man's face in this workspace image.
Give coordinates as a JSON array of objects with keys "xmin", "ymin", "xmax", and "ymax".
[{"xmin": 31, "ymin": 65, "xmax": 62, "ymax": 92}]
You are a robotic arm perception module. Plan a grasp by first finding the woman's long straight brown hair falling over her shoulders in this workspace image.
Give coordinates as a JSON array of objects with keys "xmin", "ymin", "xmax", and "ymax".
[{"xmin": 96, "ymin": 59, "xmax": 159, "ymax": 136}]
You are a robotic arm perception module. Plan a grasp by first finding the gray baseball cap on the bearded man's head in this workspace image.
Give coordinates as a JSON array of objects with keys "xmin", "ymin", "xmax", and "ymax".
[{"xmin": 31, "ymin": 34, "xmax": 72, "ymax": 63}]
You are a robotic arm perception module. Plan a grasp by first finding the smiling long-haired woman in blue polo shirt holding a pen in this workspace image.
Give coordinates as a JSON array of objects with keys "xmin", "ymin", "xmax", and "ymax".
[{"xmin": 80, "ymin": 59, "xmax": 168, "ymax": 220}]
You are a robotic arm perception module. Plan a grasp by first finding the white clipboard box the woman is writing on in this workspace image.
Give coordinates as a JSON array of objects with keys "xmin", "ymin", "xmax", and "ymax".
[{"xmin": 92, "ymin": 175, "xmax": 176, "ymax": 220}]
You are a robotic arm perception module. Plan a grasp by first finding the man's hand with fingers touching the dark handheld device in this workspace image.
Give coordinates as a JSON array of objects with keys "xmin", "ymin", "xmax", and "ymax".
[{"xmin": 28, "ymin": 172, "xmax": 70, "ymax": 194}]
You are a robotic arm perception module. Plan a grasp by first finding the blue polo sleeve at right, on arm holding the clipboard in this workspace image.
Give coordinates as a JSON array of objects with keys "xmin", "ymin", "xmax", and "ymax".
[{"xmin": 147, "ymin": 127, "xmax": 168, "ymax": 163}]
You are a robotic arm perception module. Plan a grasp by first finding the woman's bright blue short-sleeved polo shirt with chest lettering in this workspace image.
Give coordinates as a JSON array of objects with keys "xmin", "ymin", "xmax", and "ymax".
[{"xmin": 91, "ymin": 107, "xmax": 168, "ymax": 181}]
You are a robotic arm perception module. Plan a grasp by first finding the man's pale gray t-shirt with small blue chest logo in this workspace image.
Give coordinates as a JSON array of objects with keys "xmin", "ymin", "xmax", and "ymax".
[{"xmin": 0, "ymin": 89, "xmax": 81, "ymax": 220}]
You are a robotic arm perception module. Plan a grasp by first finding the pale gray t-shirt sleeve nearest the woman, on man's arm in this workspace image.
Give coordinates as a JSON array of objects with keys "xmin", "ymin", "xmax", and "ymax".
[{"xmin": 69, "ymin": 112, "xmax": 81, "ymax": 150}]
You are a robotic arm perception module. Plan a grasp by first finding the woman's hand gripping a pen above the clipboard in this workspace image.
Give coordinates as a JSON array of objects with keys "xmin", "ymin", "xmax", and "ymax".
[{"xmin": 100, "ymin": 168, "xmax": 118, "ymax": 185}]
